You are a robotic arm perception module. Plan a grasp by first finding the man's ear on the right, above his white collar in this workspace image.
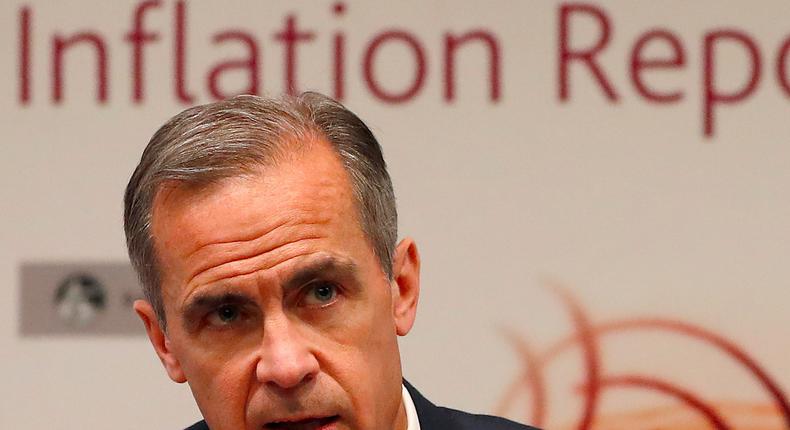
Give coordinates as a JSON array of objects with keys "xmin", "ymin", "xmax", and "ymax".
[{"xmin": 392, "ymin": 237, "xmax": 420, "ymax": 336}]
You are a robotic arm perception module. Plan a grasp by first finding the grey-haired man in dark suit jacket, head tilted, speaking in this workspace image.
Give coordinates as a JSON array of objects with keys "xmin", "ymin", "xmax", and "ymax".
[{"xmin": 124, "ymin": 93, "xmax": 540, "ymax": 430}]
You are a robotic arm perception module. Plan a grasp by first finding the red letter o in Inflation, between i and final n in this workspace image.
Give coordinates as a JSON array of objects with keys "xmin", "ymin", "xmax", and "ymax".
[{"xmin": 363, "ymin": 30, "xmax": 426, "ymax": 103}]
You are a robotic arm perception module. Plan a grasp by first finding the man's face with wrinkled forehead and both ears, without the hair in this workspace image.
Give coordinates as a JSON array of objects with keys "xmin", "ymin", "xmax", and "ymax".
[{"xmin": 135, "ymin": 141, "xmax": 419, "ymax": 430}]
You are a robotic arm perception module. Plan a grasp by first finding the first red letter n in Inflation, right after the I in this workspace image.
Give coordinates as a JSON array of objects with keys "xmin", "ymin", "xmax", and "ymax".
[{"xmin": 52, "ymin": 32, "xmax": 107, "ymax": 103}]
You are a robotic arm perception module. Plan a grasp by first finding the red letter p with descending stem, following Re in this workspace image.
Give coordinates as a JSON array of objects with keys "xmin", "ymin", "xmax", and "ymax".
[{"xmin": 703, "ymin": 30, "xmax": 761, "ymax": 136}]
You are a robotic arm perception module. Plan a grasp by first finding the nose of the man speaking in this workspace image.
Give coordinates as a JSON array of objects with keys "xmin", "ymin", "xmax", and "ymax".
[{"xmin": 256, "ymin": 315, "xmax": 319, "ymax": 388}]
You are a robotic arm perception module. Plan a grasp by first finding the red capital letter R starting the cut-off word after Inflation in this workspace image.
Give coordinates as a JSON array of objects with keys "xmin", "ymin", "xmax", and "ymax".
[{"xmin": 559, "ymin": 3, "xmax": 618, "ymax": 101}]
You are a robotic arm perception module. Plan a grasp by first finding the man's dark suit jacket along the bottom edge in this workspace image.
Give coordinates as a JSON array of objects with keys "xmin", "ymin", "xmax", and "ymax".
[{"xmin": 186, "ymin": 381, "xmax": 538, "ymax": 430}]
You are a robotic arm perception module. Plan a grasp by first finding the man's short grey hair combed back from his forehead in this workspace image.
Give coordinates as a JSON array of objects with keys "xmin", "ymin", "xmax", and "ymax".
[{"xmin": 124, "ymin": 92, "xmax": 398, "ymax": 328}]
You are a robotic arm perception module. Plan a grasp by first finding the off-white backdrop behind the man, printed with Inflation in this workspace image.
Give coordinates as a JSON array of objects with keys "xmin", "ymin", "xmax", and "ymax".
[{"xmin": 0, "ymin": 0, "xmax": 790, "ymax": 429}]
